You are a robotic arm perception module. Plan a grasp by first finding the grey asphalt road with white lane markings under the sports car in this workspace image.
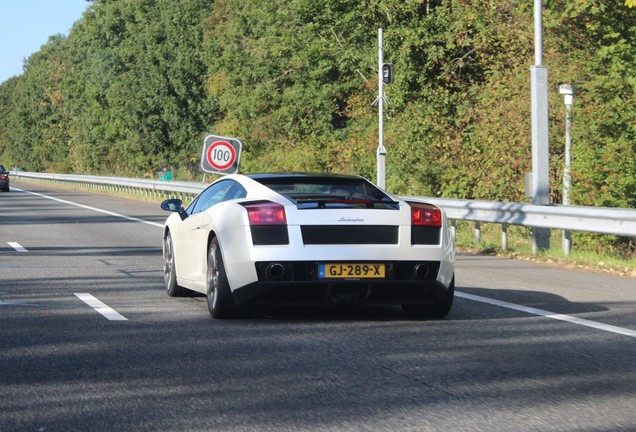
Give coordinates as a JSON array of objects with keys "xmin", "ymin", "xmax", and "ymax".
[{"xmin": 0, "ymin": 182, "xmax": 636, "ymax": 432}]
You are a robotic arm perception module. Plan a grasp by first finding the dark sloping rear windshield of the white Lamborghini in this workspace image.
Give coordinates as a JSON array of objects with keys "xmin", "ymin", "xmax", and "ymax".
[{"xmin": 256, "ymin": 177, "xmax": 397, "ymax": 209}]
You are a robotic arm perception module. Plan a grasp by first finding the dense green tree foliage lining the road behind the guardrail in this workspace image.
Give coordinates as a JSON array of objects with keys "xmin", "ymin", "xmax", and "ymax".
[{"xmin": 0, "ymin": 0, "xmax": 636, "ymax": 208}]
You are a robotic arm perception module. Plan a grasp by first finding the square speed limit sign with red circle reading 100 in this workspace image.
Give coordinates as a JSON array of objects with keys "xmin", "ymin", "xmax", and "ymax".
[{"xmin": 201, "ymin": 135, "xmax": 242, "ymax": 174}]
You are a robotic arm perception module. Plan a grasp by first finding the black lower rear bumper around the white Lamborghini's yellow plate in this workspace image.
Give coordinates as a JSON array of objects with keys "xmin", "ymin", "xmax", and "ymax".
[{"xmin": 233, "ymin": 261, "xmax": 450, "ymax": 305}]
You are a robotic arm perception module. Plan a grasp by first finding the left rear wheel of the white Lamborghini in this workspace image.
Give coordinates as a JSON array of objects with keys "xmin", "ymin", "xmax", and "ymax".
[{"xmin": 207, "ymin": 237, "xmax": 236, "ymax": 318}]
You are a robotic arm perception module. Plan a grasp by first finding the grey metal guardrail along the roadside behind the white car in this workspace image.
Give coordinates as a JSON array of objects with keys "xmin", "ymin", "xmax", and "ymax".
[{"xmin": 11, "ymin": 172, "xmax": 636, "ymax": 250}]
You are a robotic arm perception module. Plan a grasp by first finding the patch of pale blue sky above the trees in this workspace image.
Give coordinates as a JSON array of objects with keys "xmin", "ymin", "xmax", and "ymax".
[{"xmin": 0, "ymin": 0, "xmax": 90, "ymax": 83}]
